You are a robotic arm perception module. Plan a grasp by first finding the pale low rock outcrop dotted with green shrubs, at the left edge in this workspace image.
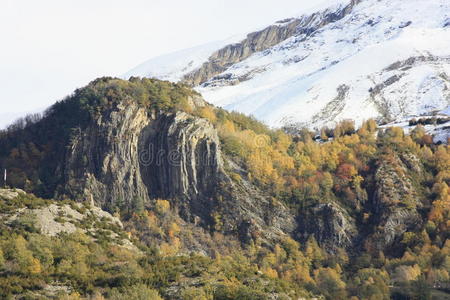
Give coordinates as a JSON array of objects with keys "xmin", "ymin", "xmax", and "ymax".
[{"xmin": 0, "ymin": 189, "xmax": 137, "ymax": 251}]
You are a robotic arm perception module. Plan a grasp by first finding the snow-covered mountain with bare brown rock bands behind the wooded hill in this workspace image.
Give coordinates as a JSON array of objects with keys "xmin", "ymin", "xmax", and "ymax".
[{"xmin": 125, "ymin": 0, "xmax": 450, "ymax": 127}]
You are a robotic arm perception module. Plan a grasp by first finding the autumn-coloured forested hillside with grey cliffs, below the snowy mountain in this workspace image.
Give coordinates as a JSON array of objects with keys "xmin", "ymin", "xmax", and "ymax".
[{"xmin": 0, "ymin": 78, "xmax": 450, "ymax": 299}]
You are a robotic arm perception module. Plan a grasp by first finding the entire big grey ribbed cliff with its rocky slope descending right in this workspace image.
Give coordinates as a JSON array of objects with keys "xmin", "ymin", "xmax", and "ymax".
[{"xmin": 59, "ymin": 99, "xmax": 295, "ymax": 242}]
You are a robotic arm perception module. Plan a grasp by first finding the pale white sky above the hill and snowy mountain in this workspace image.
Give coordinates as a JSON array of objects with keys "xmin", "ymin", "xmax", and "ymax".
[{"xmin": 0, "ymin": 0, "xmax": 330, "ymax": 128}]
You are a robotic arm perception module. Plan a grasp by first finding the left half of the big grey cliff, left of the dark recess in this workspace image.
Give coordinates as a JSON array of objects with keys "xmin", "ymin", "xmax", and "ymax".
[{"xmin": 59, "ymin": 102, "xmax": 151, "ymax": 207}]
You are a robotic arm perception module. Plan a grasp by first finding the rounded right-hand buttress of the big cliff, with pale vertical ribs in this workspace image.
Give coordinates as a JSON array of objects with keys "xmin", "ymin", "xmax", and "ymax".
[{"xmin": 139, "ymin": 112, "xmax": 223, "ymax": 218}]
